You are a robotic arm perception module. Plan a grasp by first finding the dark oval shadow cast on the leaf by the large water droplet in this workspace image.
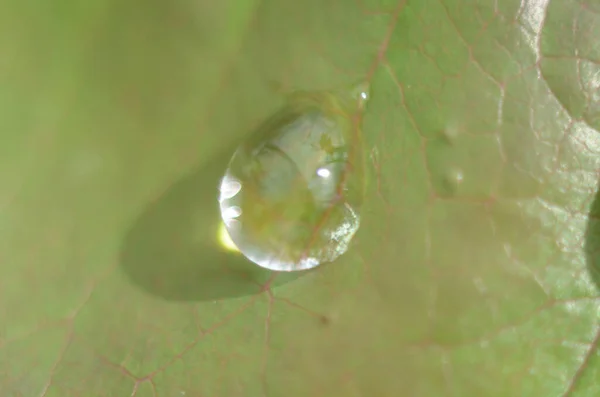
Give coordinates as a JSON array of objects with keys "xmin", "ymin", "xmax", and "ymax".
[{"xmin": 121, "ymin": 142, "xmax": 305, "ymax": 301}]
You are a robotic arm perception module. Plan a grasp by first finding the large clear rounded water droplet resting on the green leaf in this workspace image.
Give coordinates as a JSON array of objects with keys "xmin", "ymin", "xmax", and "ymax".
[{"xmin": 219, "ymin": 84, "xmax": 369, "ymax": 271}]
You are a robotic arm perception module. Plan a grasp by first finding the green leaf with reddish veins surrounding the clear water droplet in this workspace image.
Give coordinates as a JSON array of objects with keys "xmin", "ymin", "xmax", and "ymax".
[{"xmin": 0, "ymin": 0, "xmax": 600, "ymax": 397}]
